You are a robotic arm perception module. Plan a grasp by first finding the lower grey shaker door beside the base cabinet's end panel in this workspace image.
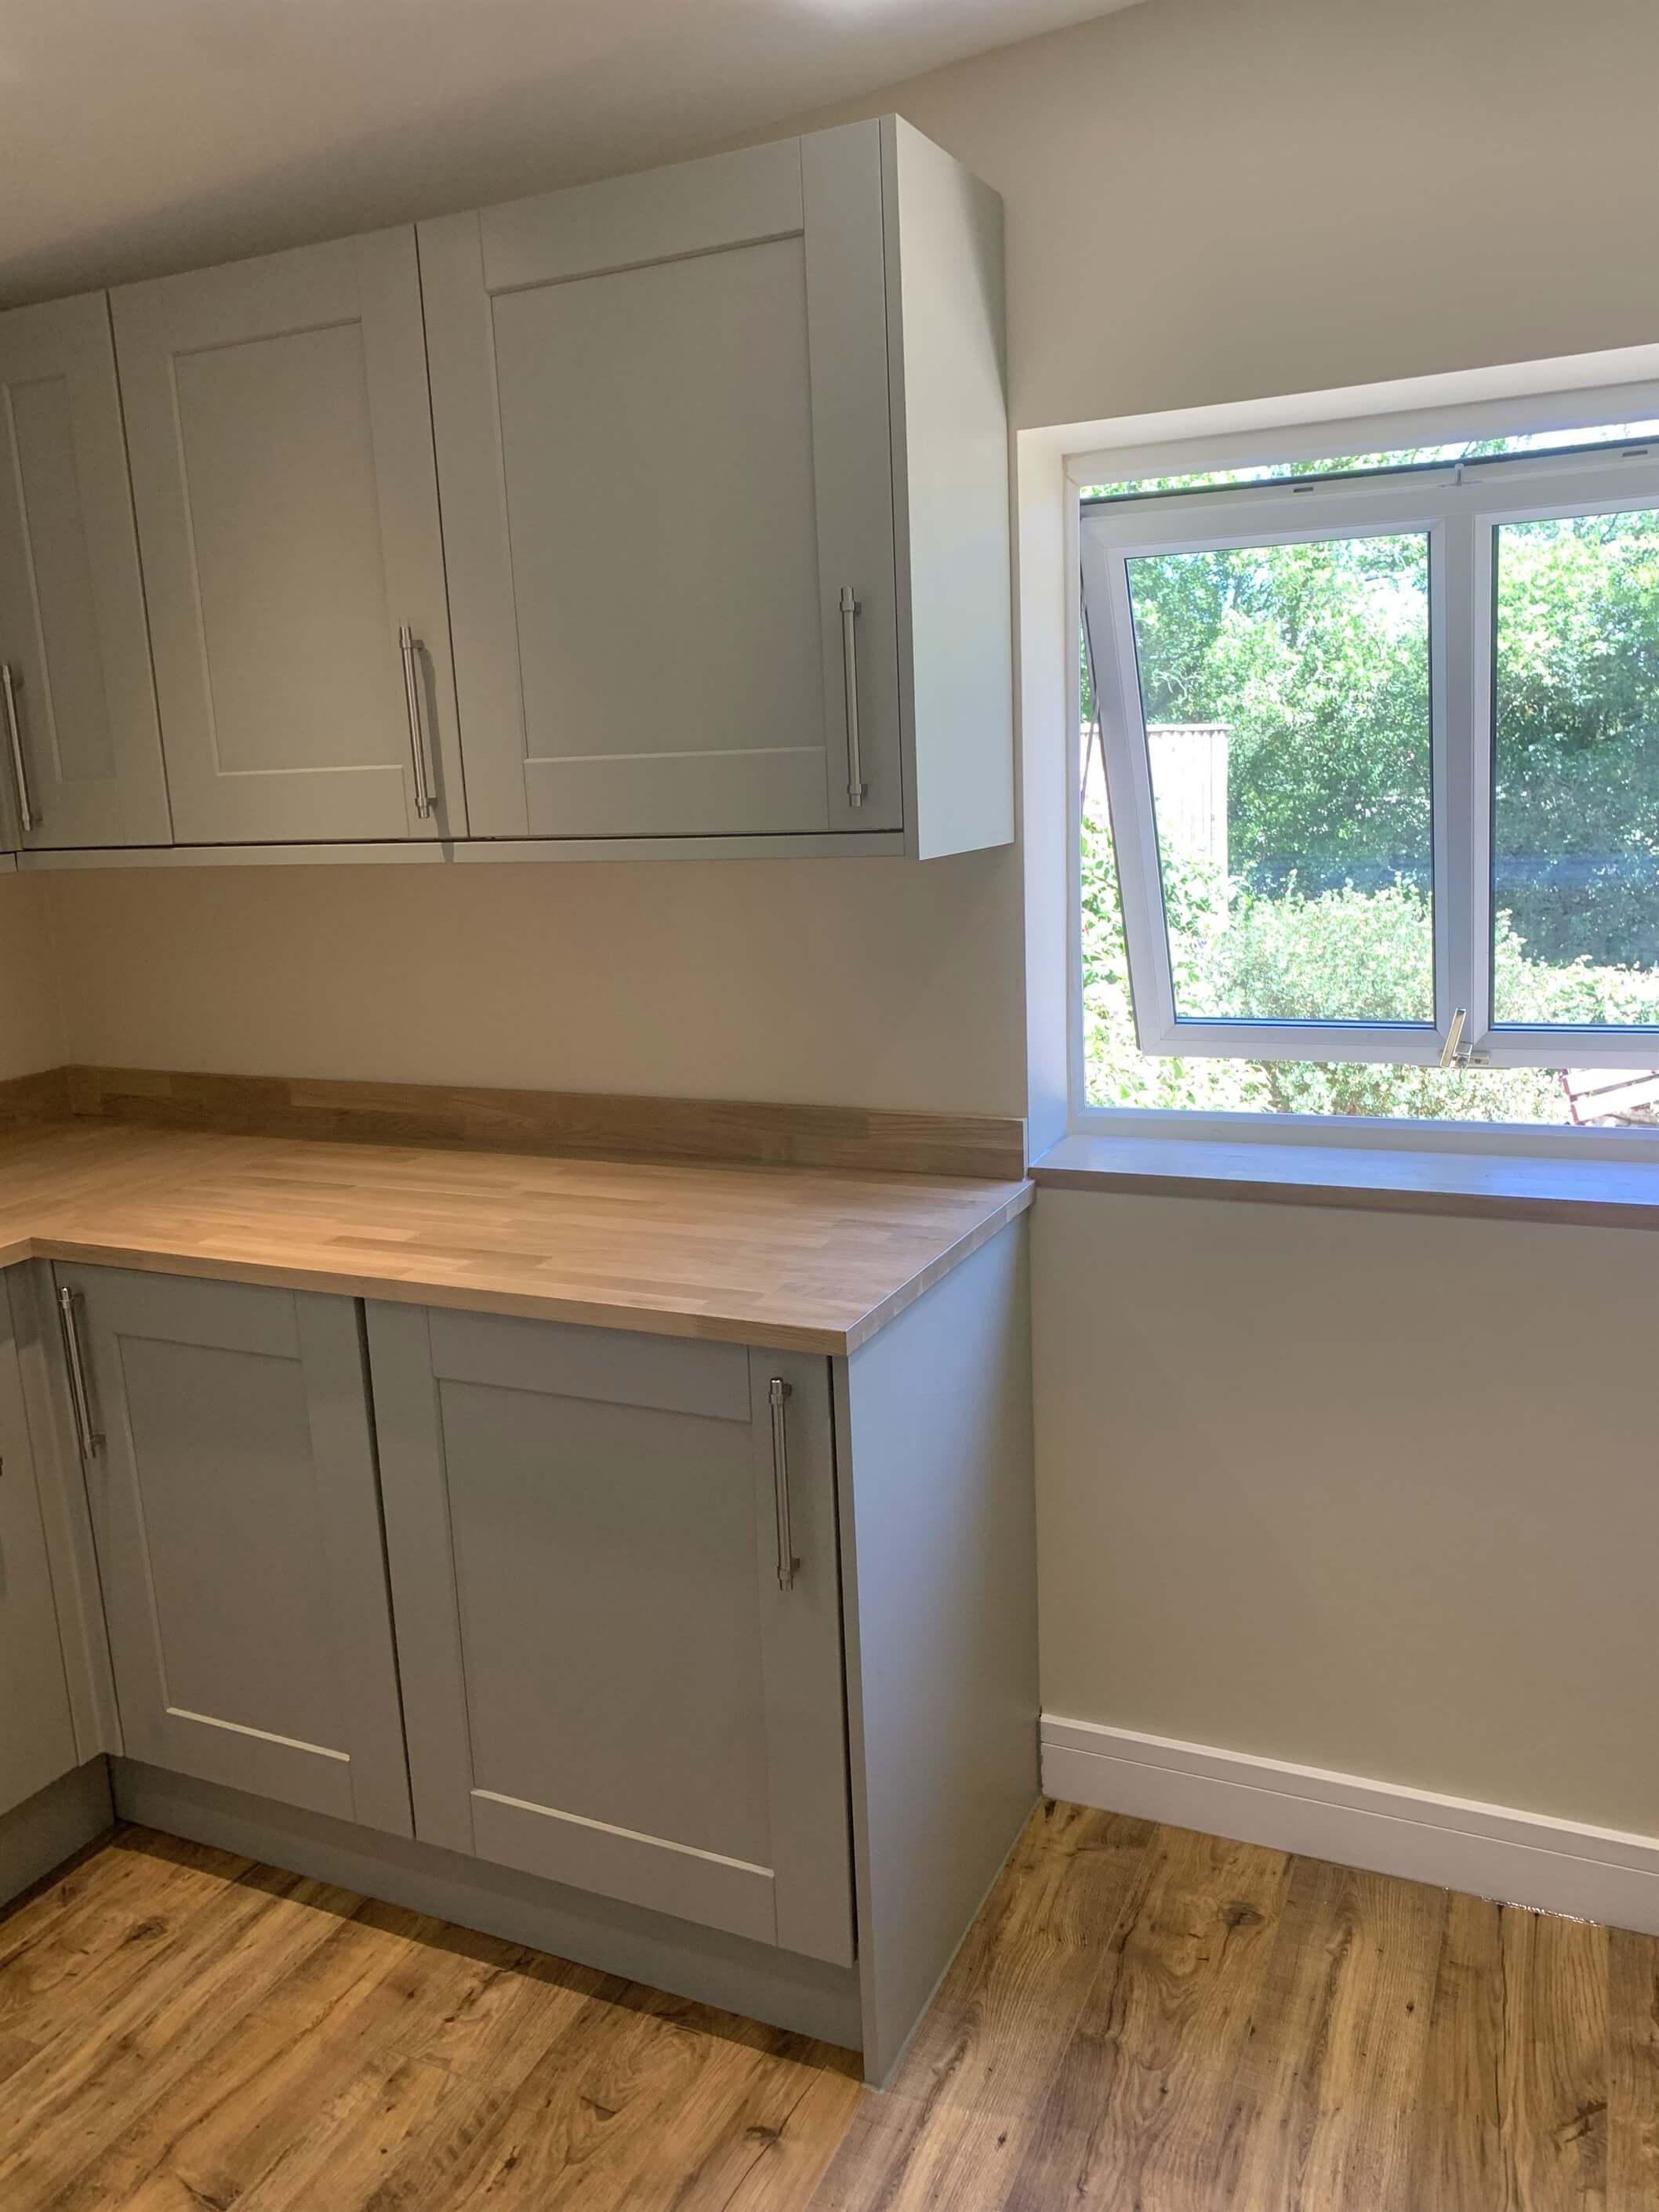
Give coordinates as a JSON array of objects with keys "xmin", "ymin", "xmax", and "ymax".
[{"xmin": 369, "ymin": 1303, "xmax": 851, "ymax": 1964}]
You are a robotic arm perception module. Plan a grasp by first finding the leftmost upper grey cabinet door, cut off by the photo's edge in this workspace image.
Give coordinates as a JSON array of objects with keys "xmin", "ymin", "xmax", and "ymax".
[{"xmin": 0, "ymin": 292, "xmax": 170, "ymax": 850}]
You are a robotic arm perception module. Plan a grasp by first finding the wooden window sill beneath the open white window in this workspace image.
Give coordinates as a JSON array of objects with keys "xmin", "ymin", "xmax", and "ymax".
[{"xmin": 1031, "ymin": 1137, "xmax": 1659, "ymax": 1230}]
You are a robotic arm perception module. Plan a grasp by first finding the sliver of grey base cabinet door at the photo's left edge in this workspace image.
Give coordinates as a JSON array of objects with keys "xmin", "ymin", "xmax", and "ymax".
[{"xmin": 0, "ymin": 1276, "xmax": 78, "ymax": 1814}]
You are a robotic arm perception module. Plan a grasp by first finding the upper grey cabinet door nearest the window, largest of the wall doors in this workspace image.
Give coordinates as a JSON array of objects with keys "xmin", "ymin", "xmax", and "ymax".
[{"xmin": 420, "ymin": 124, "xmax": 902, "ymax": 836}]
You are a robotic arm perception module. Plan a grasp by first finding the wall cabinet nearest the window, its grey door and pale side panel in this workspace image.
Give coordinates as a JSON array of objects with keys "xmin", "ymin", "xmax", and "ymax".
[{"xmin": 420, "ymin": 118, "xmax": 1013, "ymax": 854}]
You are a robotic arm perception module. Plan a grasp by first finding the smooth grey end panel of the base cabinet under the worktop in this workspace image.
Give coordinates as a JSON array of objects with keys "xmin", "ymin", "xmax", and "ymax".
[{"xmin": 836, "ymin": 1219, "xmax": 1037, "ymax": 2082}]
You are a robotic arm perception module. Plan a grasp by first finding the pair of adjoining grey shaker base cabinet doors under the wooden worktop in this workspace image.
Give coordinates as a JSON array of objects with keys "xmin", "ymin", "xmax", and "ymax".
[{"xmin": 56, "ymin": 1265, "xmax": 854, "ymax": 1967}]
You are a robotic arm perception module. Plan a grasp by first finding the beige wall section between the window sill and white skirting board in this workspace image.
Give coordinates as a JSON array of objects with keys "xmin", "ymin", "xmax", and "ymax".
[{"xmin": 1033, "ymin": 1190, "xmax": 1659, "ymax": 1833}]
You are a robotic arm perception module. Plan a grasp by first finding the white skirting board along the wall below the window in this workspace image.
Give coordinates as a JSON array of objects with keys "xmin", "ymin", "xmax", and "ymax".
[{"xmin": 1042, "ymin": 1714, "xmax": 1659, "ymax": 1935}]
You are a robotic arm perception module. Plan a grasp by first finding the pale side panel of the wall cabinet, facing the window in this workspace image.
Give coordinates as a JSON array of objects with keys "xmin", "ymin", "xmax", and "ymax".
[{"xmin": 883, "ymin": 118, "xmax": 1013, "ymax": 858}]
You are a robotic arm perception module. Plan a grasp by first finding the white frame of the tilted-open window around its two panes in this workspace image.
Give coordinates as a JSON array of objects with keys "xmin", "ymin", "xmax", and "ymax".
[{"xmin": 1071, "ymin": 440, "xmax": 1659, "ymax": 1079}]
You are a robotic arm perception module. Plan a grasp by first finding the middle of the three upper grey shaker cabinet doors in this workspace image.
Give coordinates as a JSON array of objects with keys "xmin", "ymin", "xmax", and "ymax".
[{"xmin": 113, "ymin": 230, "xmax": 464, "ymax": 845}]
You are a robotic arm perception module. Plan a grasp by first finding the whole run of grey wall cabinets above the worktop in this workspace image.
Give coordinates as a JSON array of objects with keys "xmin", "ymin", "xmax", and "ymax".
[{"xmin": 0, "ymin": 118, "xmax": 1013, "ymax": 867}]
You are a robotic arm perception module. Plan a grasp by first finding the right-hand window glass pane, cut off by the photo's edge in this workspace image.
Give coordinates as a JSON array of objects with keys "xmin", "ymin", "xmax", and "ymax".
[{"xmin": 1493, "ymin": 509, "xmax": 1659, "ymax": 1031}]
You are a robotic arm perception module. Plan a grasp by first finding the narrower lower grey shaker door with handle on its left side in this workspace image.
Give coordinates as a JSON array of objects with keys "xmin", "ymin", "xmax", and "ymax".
[{"xmin": 57, "ymin": 1265, "xmax": 412, "ymax": 1836}]
